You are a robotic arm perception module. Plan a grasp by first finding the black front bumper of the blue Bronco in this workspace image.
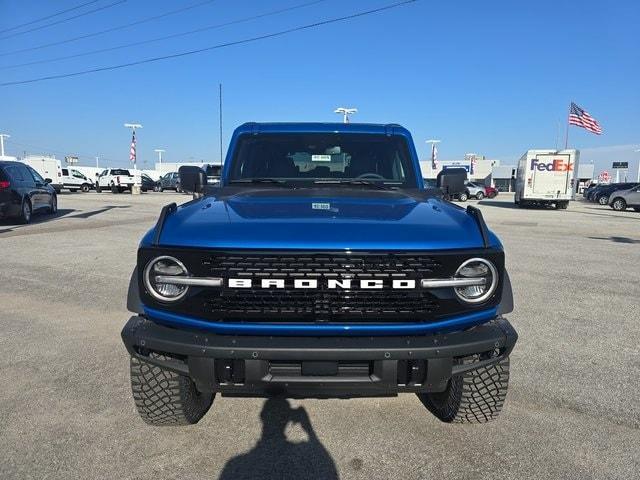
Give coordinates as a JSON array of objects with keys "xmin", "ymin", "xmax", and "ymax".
[{"xmin": 122, "ymin": 316, "xmax": 518, "ymax": 398}]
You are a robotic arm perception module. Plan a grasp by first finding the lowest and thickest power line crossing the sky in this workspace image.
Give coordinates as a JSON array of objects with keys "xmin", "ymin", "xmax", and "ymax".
[{"xmin": 0, "ymin": 0, "xmax": 418, "ymax": 87}]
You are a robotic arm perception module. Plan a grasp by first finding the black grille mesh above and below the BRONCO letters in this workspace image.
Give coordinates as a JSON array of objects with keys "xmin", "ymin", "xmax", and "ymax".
[{"xmin": 202, "ymin": 254, "xmax": 441, "ymax": 322}]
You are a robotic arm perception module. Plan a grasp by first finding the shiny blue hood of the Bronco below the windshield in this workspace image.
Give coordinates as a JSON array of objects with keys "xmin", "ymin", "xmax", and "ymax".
[{"xmin": 150, "ymin": 188, "xmax": 500, "ymax": 250}]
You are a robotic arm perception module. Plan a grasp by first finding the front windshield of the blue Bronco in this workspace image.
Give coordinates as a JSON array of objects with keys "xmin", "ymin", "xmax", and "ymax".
[{"xmin": 230, "ymin": 133, "xmax": 416, "ymax": 188}]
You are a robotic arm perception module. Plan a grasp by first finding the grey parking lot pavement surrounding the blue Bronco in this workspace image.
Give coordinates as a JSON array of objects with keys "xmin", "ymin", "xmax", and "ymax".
[{"xmin": 0, "ymin": 193, "xmax": 640, "ymax": 480}]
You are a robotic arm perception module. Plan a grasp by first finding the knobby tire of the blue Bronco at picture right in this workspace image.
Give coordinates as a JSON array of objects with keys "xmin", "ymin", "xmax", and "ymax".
[{"xmin": 418, "ymin": 355, "xmax": 509, "ymax": 423}]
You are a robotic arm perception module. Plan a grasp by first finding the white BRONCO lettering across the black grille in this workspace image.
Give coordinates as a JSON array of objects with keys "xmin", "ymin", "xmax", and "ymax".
[{"xmin": 227, "ymin": 278, "xmax": 416, "ymax": 290}]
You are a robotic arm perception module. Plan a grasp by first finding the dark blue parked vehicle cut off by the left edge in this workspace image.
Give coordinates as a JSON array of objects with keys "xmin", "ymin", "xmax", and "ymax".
[{"xmin": 0, "ymin": 161, "xmax": 58, "ymax": 223}]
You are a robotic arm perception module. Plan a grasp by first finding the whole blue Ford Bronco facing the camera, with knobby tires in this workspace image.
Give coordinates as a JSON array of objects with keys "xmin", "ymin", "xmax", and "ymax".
[{"xmin": 122, "ymin": 123, "xmax": 517, "ymax": 425}]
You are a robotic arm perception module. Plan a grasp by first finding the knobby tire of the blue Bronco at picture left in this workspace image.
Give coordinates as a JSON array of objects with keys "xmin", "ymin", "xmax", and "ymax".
[{"xmin": 131, "ymin": 353, "xmax": 215, "ymax": 426}]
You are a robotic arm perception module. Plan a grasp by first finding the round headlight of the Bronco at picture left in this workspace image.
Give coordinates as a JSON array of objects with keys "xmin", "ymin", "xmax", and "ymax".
[{"xmin": 143, "ymin": 256, "xmax": 189, "ymax": 302}]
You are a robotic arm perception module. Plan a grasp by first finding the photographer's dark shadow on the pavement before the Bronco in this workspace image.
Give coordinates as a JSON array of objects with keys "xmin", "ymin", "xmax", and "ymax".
[{"xmin": 219, "ymin": 397, "xmax": 339, "ymax": 480}]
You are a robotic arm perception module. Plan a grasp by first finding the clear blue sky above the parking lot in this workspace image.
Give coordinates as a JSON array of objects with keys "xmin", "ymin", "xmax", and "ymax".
[{"xmin": 0, "ymin": 0, "xmax": 640, "ymax": 174}]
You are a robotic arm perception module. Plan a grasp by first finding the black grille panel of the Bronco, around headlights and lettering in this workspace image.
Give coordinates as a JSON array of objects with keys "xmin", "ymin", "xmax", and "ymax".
[{"xmin": 139, "ymin": 249, "xmax": 503, "ymax": 323}]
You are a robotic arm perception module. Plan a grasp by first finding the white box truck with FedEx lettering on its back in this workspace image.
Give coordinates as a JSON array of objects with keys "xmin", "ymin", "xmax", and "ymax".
[{"xmin": 514, "ymin": 150, "xmax": 580, "ymax": 209}]
